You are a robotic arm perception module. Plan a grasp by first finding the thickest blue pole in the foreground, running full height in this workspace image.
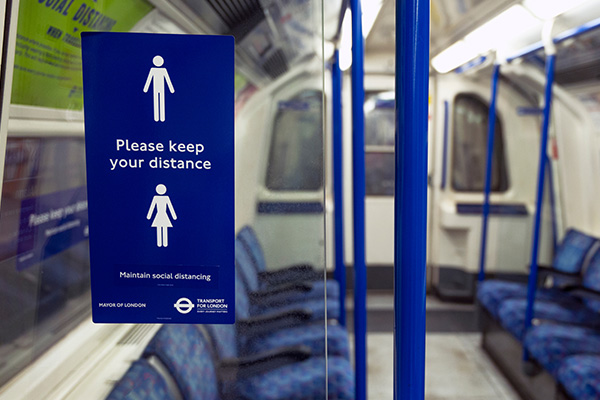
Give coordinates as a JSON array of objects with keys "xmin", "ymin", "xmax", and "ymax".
[{"xmin": 394, "ymin": 0, "xmax": 430, "ymax": 400}]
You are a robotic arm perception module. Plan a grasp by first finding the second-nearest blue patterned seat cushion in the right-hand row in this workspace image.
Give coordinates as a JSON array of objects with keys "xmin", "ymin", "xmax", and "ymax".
[{"xmin": 524, "ymin": 324, "xmax": 600, "ymax": 377}]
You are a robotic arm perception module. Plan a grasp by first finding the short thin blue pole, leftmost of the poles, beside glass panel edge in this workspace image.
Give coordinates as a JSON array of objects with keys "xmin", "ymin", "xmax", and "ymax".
[{"xmin": 331, "ymin": 50, "xmax": 346, "ymax": 326}]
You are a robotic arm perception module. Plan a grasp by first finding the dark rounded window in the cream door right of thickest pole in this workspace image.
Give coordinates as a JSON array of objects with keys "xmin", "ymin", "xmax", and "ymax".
[{"xmin": 452, "ymin": 94, "xmax": 508, "ymax": 192}]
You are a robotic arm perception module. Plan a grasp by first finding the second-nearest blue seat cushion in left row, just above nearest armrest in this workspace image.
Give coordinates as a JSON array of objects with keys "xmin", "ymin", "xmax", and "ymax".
[{"xmin": 247, "ymin": 324, "xmax": 350, "ymax": 359}]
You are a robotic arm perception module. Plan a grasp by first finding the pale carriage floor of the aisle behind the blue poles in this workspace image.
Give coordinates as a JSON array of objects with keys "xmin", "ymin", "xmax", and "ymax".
[{"xmin": 347, "ymin": 293, "xmax": 520, "ymax": 400}]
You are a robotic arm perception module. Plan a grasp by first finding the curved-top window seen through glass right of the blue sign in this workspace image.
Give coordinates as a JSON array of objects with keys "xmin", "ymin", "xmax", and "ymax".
[{"xmin": 266, "ymin": 90, "xmax": 323, "ymax": 191}]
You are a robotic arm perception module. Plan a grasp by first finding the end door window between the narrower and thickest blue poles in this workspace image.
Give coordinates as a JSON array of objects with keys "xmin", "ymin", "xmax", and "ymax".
[{"xmin": 365, "ymin": 92, "xmax": 396, "ymax": 196}]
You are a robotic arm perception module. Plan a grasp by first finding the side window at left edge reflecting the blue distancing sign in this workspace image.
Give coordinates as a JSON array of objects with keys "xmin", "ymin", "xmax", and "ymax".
[{"xmin": 0, "ymin": 137, "xmax": 90, "ymax": 385}]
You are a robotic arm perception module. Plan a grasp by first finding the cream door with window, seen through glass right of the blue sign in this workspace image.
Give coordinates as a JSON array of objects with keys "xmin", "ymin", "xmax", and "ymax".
[{"xmin": 241, "ymin": 70, "xmax": 326, "ymax": 268}]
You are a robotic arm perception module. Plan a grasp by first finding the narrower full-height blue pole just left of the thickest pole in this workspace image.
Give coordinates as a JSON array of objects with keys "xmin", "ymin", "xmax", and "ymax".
[{"xmin": 350, "ymin": 0, "xmax": 367, "ymax": 400}]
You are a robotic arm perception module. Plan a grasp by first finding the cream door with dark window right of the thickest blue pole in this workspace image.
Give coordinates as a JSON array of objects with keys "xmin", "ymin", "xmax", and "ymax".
[{"xmin": 429, "ymin": 73, "xmax": 545, "ymax": 298}]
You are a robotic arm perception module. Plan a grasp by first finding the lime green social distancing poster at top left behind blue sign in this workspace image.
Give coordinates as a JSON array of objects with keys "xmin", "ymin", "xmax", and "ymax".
[{"xmin": 11, "ymin": 0, "xmax": 153, "ymax": 110}]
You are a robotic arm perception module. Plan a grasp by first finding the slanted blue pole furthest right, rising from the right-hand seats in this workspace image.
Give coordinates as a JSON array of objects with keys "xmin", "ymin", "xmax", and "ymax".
[{"xmin": 523, "ymin": 54, "xmax": 556, "ymax": 361}]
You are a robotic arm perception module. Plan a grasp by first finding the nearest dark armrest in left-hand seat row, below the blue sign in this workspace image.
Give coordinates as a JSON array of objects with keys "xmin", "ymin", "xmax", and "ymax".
[{"xmin": 218, "ymin": 345, "xmax": 312, "ymax": 383}]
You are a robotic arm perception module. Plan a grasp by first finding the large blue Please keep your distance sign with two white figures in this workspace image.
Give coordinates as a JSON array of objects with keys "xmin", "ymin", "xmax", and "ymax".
[{"xmin": 82, "ymin": 33, "xmax": 235, "ymax": 324}]
